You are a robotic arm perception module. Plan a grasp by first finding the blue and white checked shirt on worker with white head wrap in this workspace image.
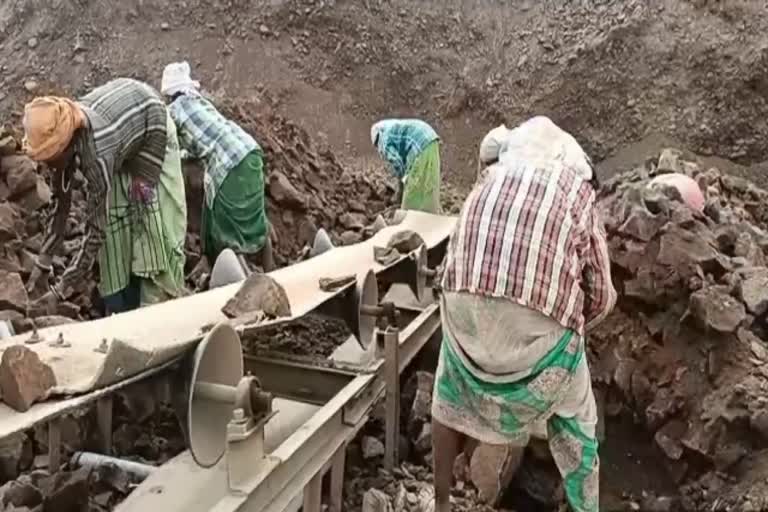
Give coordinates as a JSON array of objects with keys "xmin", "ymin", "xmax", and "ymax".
[{"xmin": 170, "ymin": 94, "xmax": 261, "ymax": 208}]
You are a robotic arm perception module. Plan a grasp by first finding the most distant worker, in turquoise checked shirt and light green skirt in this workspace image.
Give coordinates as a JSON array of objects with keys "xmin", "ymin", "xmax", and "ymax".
[{"xmin": 371, "ymin": 119, "xmax": 440, "ymax": 214}]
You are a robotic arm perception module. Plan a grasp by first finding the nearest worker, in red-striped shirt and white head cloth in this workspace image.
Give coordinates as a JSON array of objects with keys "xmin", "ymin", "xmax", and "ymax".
[{"xmin": 432, "ymin": 118, "xmax": 616, "ymax": 512}]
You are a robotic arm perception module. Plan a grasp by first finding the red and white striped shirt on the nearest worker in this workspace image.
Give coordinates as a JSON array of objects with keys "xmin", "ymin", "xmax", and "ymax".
[{"xmin": 442, "ymin": 159, "xmax": 616, "ymax": 334}]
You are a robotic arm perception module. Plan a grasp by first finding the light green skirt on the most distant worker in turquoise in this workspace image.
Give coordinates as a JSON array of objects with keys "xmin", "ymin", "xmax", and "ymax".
[{"xmin": 401, "ymin": 141, "xmax": 440, "ymax": 214}]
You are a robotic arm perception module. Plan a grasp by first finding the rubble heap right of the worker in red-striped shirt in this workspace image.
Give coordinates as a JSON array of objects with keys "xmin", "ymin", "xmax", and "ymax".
[{"xmin": 589, "ymin": 150, "xmax": 768, "ymax": 510}]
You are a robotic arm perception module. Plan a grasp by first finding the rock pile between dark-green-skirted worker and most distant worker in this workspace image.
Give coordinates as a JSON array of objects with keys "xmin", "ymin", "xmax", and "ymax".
[{"xmin": 222, "ymin": 95, "xmax": 395, "ymax": 264}]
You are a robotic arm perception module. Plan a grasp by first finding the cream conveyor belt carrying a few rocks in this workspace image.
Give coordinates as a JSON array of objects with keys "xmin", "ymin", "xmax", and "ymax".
[{"xmin": 0, "ymin": 212, "xmax": 456, "ymax": 438}]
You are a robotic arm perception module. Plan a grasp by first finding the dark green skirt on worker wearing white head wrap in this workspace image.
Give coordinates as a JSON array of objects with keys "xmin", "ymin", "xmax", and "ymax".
[{"xmin": 202, "ymin": 151, "xmax": 267, "ymax": 262}]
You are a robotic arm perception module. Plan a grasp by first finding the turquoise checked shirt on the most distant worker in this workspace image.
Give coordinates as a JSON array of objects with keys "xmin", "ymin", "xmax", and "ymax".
[{"xmin": 376, "ymin": 119, "xmax": 439, "ymax": 180}]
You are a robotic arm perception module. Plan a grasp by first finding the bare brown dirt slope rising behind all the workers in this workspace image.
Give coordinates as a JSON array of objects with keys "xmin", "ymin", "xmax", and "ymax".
[{"xmin": 7, "ymin": 0, "xmax": 768, "ymax": 193}]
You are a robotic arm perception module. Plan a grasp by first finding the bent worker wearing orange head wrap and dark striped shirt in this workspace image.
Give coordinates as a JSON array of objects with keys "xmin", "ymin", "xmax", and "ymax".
[{"xmin": 23, "ymin": 78, "xmax": 186, "ymax": 313}]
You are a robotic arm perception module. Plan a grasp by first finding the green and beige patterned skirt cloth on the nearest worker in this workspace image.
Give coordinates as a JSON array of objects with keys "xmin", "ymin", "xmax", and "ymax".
[{"xmin": 433, "ymin": 331, "xmax": 599, "ymax": 512}]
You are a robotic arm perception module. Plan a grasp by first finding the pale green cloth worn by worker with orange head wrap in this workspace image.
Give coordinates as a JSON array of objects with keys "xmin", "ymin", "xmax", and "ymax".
[{"xmin": 99, "ymin": 112, "xmax": 187, "ymax": 305}]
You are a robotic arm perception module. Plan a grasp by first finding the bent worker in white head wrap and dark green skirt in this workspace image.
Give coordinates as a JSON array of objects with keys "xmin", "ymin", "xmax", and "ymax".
[{"xmin": 160, "ymin": 62, "xmax": 274, "ymax": 272}]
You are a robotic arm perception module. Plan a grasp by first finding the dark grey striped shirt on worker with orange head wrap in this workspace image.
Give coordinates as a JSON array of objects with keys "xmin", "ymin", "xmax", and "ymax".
[{"xmin": 42, "ymin": 78, "xmax": 168, "ymax": 295}]
